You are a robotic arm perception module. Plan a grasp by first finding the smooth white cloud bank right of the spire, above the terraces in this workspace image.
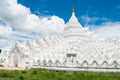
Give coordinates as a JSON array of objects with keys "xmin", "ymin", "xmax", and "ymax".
[{"xmin": 89, "ymin": 22, "xmax": 120, "ymax": 39}]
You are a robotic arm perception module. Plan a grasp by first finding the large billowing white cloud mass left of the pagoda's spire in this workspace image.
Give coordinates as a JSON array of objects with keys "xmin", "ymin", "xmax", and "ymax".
[{"xmin": 0, "ymin": 0, "xmax": 64, "ymax": 46}]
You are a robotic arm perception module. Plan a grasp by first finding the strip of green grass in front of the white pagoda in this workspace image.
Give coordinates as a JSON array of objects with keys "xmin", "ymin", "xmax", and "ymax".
[{"xmin": 0, "ymin": 69, "xmax": 120, "ymax": 80}]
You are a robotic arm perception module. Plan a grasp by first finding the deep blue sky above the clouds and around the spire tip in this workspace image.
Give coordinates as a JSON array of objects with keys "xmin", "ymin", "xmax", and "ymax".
[{"xmin": 18, "ymin": 0, "xmax": 120, "ymax": 25}]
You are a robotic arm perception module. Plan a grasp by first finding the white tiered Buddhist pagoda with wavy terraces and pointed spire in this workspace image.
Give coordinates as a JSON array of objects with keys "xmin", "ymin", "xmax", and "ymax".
[{"xmin": 0, "ymin": 9, "xmax": 120, "ymax": 72}]
